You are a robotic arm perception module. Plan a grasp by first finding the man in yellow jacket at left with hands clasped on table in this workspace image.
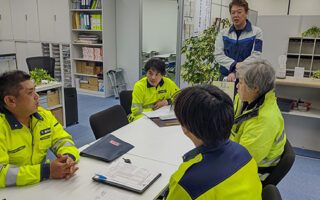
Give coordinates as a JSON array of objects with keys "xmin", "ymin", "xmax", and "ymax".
[{"xmin": 0, "ymin": 70, "xmax": 79, "ymax": 188}]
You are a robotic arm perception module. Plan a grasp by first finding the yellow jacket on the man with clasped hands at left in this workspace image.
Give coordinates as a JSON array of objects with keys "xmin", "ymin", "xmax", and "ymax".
[{"xmin": 0, "ymin": 107, "xmax": 79, "ymax": 188}]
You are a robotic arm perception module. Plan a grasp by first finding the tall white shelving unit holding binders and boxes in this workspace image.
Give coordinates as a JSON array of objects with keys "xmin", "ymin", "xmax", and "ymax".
[{"xmin": 69, "ymin": 0, "xmax": 117, "ymax": 97}]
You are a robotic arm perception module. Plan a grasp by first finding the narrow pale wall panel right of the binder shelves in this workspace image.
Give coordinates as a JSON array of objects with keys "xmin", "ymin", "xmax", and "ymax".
[{"xmin": 116, "ymin": 0, "xmax": 140, "ymax": 89}]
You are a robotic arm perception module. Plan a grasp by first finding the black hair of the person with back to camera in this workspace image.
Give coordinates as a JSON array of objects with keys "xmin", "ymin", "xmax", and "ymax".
[{"xmin": 174, "ymin": 85, "xmax": 234, "ymax": 145}]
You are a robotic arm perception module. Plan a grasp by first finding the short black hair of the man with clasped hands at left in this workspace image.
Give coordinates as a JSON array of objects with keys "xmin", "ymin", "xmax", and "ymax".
[{"xmin": 0, "ymin": 70, "xmax": 30, "ymax": 106}]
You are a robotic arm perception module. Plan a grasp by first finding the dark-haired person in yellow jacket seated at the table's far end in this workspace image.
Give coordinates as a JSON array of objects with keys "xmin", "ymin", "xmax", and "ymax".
[{"xmin": 129, "ymin": 58, "xmax": 179, "ymax": 122}]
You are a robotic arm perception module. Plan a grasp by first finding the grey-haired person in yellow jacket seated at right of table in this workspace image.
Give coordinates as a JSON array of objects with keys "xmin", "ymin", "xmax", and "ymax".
[{"xmin": 230, "ymin": 61, "xmax": 286, "ymax": 181}]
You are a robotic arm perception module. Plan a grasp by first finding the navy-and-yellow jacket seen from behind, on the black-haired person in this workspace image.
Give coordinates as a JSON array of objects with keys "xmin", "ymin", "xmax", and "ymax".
[{"xmin": 164, "ymin": 140, "xmax": 262, "ymax": 200}]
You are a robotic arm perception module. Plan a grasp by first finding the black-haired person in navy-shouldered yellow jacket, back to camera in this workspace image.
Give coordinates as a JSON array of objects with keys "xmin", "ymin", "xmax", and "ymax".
[{"xmin": 164, "ymin": 85, "xmax": 262, "ymax": 200}]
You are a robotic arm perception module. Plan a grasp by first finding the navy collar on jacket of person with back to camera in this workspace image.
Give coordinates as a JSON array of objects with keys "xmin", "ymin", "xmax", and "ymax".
[{"xmin": 183, "ymin": 140, "xmax": 230, "ymax": 162}]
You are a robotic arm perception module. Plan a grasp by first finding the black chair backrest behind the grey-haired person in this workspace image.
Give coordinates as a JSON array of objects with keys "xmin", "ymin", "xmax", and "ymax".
[{"xmin": 262, "ymin": 140, "xmax": 296, "ymax": 186}]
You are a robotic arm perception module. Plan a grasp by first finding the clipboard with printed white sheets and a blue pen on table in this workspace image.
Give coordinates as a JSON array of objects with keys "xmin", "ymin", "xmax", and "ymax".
[{"xmin": 92, "ymin": 160, "xmax": 161, "ymax": 194}]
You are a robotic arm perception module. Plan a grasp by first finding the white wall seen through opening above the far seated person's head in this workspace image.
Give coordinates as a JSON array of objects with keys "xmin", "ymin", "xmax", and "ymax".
[{"xmin": 142, "ymin": 0, "xmax": 178, "ymax": 54}]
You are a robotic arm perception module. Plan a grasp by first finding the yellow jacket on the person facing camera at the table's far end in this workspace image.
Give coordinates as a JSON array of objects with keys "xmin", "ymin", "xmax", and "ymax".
[{"xmin": 129, "ymin": 77, "xmax": 179, "ymax": 122}]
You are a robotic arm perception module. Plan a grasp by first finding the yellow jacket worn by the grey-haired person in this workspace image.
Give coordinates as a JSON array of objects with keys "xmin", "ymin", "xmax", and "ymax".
[{"xmin": 230, "ymin": 90, "xmax": 286, "ymax": 167}]
